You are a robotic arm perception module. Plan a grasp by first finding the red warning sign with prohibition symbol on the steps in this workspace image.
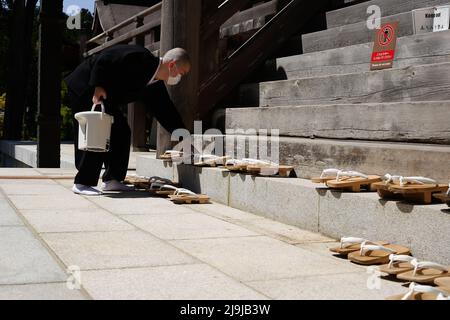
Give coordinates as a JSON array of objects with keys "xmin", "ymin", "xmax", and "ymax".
[{"xmin": 370, "ymin": 22, "xmax": 398, "ymax": 70}]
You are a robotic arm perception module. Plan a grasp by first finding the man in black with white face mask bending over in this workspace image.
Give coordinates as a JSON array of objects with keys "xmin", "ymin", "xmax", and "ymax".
[{"xmin": 65, "ymin": 45, "xmax": 191, "ymax": 196}]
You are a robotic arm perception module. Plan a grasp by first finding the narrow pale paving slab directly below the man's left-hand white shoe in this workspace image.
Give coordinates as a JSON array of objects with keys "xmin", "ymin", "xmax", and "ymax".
[{"xmin": 9, "ymin": 194, "xmax": 95, "ymax": 210}]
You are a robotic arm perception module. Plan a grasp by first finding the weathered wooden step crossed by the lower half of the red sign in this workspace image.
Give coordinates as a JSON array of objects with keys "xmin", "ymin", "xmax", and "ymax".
[{"xmin": 258, "ymin": 30, "xmax": 450, "ymax": 81}]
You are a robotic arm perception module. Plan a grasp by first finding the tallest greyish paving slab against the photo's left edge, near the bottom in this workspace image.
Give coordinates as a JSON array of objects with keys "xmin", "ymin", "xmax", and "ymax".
[{"xmin": 0, "ymin": 227, "xmax": 67, "ymax": 285}]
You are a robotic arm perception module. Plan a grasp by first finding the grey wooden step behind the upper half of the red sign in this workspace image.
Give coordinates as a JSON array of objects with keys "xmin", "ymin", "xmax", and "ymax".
[{"xmin": 302, "ymin": 2, "xmax": 450, "ymax": 53}]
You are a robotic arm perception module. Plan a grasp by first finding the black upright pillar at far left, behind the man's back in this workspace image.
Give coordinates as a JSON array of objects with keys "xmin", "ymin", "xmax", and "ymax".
[{"xmin": 37, "ymin": 0, "xmax": 63, "ymax": 168}]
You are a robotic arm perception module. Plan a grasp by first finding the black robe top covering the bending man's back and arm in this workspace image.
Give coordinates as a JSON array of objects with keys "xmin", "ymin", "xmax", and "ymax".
[{"xmin": 64, "ymin": 45, "xmax": 186, "ymax": 132}]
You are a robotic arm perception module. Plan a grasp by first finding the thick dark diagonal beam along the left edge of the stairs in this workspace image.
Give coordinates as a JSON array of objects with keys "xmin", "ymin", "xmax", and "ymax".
[{"xmin": 199, "ymin": 0, "xmax": 325, "ymax": 117}]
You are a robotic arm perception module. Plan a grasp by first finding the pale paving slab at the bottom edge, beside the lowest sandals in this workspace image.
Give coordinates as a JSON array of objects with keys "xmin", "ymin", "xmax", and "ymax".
[{"xmin": 246, "ymin": 272, "xmax": 408, "ymax": 300}]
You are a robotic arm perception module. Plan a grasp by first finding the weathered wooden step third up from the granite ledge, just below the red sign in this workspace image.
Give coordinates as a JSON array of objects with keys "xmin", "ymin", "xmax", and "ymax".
[{"xmin": 240, "ymin": 63, "xmax": 450, "ymax": 107}]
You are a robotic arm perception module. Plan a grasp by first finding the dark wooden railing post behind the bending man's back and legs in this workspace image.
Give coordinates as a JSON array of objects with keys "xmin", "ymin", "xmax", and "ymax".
[{"xmin": 128, "ymin": 18, "xmax": 148, "ymax": 152}]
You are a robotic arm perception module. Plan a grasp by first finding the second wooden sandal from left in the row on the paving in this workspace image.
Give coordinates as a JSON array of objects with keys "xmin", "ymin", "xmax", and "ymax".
[{"xmin": 348, "ymin": 242, "xmax": 411, "ymax": 265}]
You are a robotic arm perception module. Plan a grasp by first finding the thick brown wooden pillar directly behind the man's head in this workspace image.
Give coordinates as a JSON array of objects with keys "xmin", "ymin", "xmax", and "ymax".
[{"xmin": 158, "ymin": 0, "xmax": 203, "ymax": 154}]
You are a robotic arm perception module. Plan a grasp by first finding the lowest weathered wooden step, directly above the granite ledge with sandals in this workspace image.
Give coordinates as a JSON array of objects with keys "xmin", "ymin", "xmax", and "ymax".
[{"xmin": 225, "ymin": 132, "xmax": 450, "ymax": 183}]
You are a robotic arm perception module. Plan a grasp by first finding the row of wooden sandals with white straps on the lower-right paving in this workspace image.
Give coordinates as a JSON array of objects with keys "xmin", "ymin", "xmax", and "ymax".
[{"xmin": 330, "ymin": 237, "xmax": 450, "ymax": 300}]
